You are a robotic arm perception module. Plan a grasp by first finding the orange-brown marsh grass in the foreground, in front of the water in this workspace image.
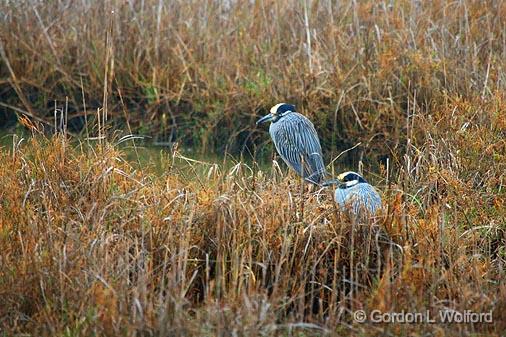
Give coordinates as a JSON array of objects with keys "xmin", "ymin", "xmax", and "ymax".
[{"xmin": 0, "ymin": 113, "xmax": 506, "ymax": 336}]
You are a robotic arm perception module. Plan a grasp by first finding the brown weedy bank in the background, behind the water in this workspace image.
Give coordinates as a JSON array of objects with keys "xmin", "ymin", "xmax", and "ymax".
[{"xmin": 0, "ymin": 0, "xmax": 506, "ymax": 159}]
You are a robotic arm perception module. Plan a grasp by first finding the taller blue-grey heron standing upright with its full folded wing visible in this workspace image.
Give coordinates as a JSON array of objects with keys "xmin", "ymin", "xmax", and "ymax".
[{"xmin": 257, "ymin": 103, "xmax": 326, "ymax": 185}]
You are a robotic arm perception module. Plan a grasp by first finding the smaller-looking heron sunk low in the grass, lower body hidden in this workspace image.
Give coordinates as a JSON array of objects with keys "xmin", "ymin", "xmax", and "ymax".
[{"xmin": 335, "ymin": 171, "xmax": 381, "ymax": 215}]
